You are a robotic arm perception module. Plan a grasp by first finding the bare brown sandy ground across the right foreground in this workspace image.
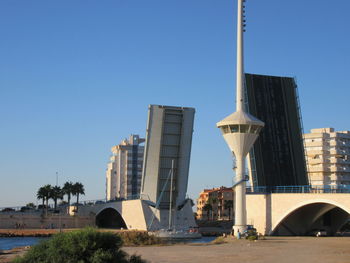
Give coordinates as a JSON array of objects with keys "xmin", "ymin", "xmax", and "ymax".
[{"xmin": 124, "ymin": 237, "xmax": 350, "ymax": 263}]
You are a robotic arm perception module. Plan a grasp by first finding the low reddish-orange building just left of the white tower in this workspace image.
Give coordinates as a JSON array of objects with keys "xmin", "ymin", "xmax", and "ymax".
[{"xmin": 197, "ymin": 186, "xmax": 233, "ymax": 220}]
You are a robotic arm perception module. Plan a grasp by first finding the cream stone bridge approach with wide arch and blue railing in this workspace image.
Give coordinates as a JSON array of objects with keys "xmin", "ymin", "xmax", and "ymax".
[{"xmin": 247, "ymin": 186, "xmax": 350, "ymax": 236}]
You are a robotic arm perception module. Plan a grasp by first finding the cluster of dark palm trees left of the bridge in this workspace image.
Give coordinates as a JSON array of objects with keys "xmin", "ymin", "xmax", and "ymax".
[{"xmin": 36, "ymin": 182, "xmax": 85, "ymax": 214}]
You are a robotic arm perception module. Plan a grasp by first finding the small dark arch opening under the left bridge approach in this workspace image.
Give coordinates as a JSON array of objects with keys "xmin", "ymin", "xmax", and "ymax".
[{"xmin": 95, "ymin": 207, "xmax": 127, "ymax": 229}]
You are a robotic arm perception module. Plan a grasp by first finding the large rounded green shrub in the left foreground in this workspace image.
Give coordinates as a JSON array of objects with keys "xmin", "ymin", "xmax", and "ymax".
[{"xmin": 14, "ymin": 228, "xmax": 145, "ymax": 263}]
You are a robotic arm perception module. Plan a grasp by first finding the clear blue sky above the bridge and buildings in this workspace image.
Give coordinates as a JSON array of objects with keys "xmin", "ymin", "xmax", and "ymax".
[{"xmin": 0, "ymin": 0, "xmax": 350, "ymax": 207}]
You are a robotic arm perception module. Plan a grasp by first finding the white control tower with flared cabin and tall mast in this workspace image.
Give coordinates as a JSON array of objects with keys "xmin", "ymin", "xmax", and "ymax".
[{"xmin": 216, "ymin": 0, "xmax": 264, "ymax": 236}]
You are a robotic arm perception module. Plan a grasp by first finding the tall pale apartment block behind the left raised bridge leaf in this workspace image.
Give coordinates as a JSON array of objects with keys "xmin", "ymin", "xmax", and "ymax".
[{"xmin": 106, "ymin": 135, "xmax": 145, "ymax": 200}]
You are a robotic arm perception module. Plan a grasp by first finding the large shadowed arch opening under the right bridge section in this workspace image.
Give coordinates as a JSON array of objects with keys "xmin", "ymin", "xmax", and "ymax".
[{"xmin": 270, "ymin": 199, "xmax": 350, "ymax": 236}]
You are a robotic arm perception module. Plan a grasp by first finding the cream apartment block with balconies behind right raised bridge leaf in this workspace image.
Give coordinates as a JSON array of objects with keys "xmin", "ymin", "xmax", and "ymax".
[{"xmin": 304, "ymin": 128, "xmax": 350, "ymax": 188}]
